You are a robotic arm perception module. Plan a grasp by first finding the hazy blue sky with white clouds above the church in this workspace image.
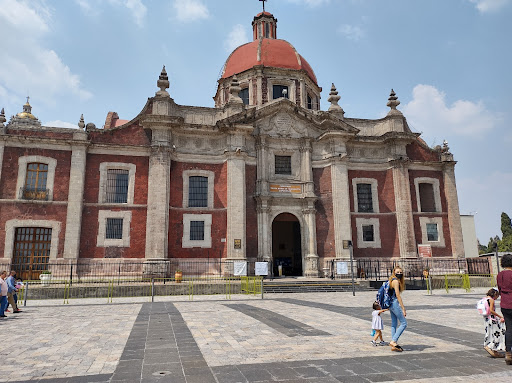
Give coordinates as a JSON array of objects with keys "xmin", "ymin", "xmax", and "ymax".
[{"xmin": 0, "ymin": 0, "xmax": 512, "ymax": 244}]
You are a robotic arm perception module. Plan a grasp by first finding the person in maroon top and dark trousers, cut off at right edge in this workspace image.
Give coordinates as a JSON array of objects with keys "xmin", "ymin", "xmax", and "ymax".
[{"xmin": 496, "ymin": 254, "xmax": 512, "ymax": 365}]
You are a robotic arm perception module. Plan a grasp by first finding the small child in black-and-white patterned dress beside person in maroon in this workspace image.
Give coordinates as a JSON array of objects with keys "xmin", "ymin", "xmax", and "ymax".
[{"xmin": 484, "ymin": 288, "xmax": 505, "ymax": 358}]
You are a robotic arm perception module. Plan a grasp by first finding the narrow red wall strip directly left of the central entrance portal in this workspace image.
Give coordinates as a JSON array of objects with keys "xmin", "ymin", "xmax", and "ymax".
[{"xmin": 245, "ymin": 165, "xmax": 258, "ymax": 258}]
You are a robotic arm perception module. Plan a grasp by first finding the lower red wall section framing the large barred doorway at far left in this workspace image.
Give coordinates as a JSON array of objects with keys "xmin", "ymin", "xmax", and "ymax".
[{"xmin": 0, "ymin": 204, "xmax": 67, "ymax": 258}]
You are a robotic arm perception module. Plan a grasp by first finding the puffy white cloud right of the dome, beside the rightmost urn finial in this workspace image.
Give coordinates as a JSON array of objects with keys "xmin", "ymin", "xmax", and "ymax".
[{"xmin": 403, "ymin": 84, "xmax": 500, "ymax": 137}]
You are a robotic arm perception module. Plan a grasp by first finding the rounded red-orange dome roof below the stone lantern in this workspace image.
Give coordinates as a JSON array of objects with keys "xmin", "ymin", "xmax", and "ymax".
[{"xmin": 222, "ymin": 39, "xmax": 318, "ymax": 85}]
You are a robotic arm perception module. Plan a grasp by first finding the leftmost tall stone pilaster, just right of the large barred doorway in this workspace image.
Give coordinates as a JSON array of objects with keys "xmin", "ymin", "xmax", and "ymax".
[{"xmin": 64, "ymin": 136, "xmax": 87, "ymax": 260}]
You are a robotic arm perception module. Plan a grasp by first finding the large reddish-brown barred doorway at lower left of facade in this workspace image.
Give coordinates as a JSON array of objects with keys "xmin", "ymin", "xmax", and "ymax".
[{"xmin": 12, "ymin": 227, "xmax": 52, "ymax": 280}]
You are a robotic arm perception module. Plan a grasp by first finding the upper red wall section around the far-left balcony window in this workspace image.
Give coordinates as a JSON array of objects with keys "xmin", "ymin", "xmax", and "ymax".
[{"xmin": 0, "ymin": 147, "xmax": 71, "ymax": 201}]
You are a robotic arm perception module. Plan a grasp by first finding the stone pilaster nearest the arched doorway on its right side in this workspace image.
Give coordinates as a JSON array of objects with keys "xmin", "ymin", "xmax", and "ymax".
[{"xmin": 331, "ymin": 160, "xmax": 352, "ymax": 259}]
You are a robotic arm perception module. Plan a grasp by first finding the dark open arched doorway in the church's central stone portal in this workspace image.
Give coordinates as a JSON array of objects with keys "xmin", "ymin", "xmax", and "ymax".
[{"xmin": 272, "ymin": 213, "xmax": 303, "ymax": 276}]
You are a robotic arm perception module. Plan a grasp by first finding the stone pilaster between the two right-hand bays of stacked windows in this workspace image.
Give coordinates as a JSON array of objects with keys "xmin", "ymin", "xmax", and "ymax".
[{"xmin": 391, "ymin": 160, "xmax": 418, "ymax": 258}]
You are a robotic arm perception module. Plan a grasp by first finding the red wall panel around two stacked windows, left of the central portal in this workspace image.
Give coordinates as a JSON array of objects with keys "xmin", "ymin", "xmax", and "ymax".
[{"xmin": 169, "ymin": 161, "xmax": 227, "ymax": 258}]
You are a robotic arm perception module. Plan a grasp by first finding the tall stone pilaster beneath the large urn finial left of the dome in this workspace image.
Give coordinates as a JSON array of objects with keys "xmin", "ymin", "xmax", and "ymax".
[{"xmin": 146, "ymin": 129, "xmax": 171, "ymax": 259}]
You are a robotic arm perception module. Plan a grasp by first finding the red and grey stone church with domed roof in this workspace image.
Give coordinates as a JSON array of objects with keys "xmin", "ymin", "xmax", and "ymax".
[{"xmin": 0, "ymin": 11, "xmax": 464, "ymax": 278}]
